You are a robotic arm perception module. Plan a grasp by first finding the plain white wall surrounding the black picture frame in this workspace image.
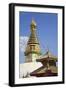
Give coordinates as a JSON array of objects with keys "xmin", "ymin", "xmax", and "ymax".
[{"xmin": 0, "ymin": 0, "xmax": 66, "ymax": 90}]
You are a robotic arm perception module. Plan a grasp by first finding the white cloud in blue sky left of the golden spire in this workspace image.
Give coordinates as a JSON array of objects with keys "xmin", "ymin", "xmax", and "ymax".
[{"xmin": 19, "ymin": 36, "xmax": 28, "ymax": 52}]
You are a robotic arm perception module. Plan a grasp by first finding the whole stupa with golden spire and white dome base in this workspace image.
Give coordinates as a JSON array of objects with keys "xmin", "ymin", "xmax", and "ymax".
[{"xmin": 20, "ymin": 19, "xmax": 42, "ymax": 78}]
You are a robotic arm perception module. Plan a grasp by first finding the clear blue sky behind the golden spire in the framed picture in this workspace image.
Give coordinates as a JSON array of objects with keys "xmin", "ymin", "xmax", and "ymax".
[{"xmin": 19, "ymin": 12, "xmax": 58, "ymax": 63}]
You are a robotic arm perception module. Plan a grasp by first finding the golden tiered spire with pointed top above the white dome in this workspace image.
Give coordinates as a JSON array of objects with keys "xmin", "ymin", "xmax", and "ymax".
[{"xmin": 25, "ymin": 19, "xmax": 40, "ymax": 56}]
